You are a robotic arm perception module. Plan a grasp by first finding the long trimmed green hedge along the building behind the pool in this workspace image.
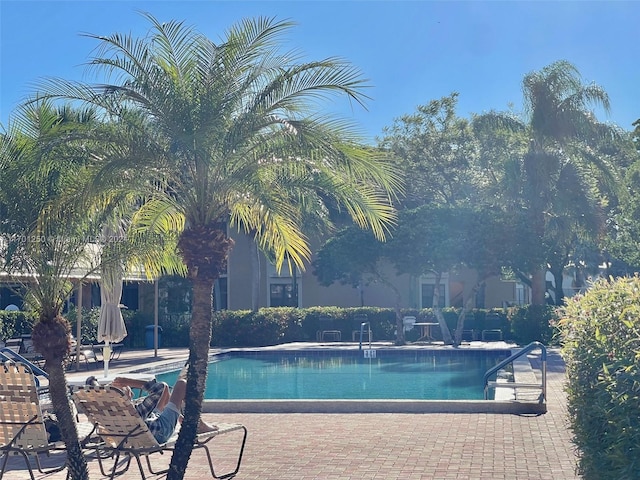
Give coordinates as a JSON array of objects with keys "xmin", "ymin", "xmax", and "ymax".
[{"xmin": 0, "ymin": 307, "xmax": 554, "ymax": 348}]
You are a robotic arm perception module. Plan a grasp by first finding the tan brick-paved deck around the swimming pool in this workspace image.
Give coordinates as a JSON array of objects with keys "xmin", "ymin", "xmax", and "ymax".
[{"xmin": 3, "ymin": 345, "xmax": 579, "ymax": 480}]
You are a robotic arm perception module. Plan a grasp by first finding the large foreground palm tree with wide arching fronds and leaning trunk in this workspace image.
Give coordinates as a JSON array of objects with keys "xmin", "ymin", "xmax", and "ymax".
[{"xmin": 44, "ymin": 15, "xmax": 400, "ymax": 479}]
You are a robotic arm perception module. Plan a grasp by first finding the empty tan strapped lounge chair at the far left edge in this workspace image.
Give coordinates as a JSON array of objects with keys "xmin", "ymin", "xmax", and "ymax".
[{"xmin": 0, "ymin": 361, "xmax": 94, "ymax": 480}]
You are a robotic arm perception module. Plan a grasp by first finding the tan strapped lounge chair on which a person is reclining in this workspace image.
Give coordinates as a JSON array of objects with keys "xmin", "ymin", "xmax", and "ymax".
[{"xmin": 72, "ymin": 385, "xmax": 247, "ymax": 479}]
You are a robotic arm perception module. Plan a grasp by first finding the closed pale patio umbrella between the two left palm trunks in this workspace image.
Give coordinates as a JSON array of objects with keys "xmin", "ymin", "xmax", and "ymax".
[{"xmin": 98, "ymin": 265, "xmax": 127, "ymax": 377}]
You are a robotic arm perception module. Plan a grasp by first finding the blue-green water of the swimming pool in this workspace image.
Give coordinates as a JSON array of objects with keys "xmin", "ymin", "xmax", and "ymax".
[{"xmin": 157, "ymin": 350, "xmax": 508, "ymax": 400}]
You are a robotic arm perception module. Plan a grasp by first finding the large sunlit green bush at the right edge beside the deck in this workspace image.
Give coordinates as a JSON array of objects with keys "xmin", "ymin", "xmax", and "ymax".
[{"xmin": 560, "ymin": 277, "xmax": 640, "ymax": 480}]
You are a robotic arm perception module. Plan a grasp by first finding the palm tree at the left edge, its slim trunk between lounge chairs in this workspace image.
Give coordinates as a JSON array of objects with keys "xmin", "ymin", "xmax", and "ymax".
[{"xmin": 0, "ymin": 102, "xmax": 102, "ymax": 479}]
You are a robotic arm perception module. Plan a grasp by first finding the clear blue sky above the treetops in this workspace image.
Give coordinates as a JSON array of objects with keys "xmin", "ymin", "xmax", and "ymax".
[{"xmin": 0, "ymin": 0, "xmax": 640, "ymax": 139}]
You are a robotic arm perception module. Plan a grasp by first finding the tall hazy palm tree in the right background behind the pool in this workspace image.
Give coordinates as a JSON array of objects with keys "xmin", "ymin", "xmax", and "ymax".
[{"xmin": 474, "ymin": 61, "xmax": 617, "ymax": 304}]
